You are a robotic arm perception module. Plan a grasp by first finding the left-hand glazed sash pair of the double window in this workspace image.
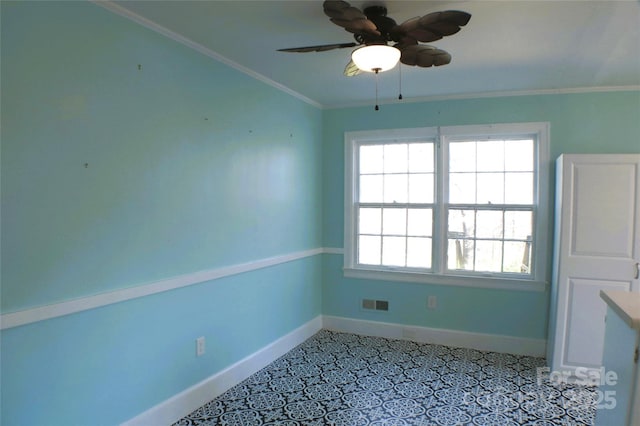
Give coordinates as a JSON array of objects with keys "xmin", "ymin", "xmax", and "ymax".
[{"xmin": 357, "ymin": 141, "xmax": 435, "ymax": 269}]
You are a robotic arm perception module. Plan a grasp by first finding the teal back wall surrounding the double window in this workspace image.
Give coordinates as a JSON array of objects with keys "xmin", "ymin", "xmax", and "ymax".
[{"xmin": 322, "ymin": 91, "xmax": 640, "ymax": 339}]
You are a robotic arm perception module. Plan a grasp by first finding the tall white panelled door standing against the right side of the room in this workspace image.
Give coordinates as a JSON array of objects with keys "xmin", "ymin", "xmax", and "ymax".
[{"xmin": 547, "ymin": 154, "xmax": 640, "ymax": 375}]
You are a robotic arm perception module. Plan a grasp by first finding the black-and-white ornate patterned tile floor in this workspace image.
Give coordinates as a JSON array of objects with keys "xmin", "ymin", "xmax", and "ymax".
[{"xmin": 175, "ymin": 330, "xmax": 597, "ymax": 426}]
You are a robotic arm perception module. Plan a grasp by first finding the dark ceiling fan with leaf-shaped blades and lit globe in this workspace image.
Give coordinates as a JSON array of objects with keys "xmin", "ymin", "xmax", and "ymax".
[{"xmin": 279, "ymin": 0, "xmax": 471, "ymax": 76}]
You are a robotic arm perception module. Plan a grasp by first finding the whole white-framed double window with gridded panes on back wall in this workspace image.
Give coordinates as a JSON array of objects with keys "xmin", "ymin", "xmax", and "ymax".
[{"xmin": 345, "ymin": 123, "xmax": 548, "ymax": 289}]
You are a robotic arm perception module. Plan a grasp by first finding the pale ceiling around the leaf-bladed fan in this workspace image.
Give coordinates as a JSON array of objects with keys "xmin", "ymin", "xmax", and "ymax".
[{"xmin": 107, "ymin": 0, "xmax": 640, "ymax": 107}]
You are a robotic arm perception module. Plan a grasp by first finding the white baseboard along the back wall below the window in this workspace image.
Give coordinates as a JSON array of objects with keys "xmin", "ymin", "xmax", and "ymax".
[{"xmin": 322, "ymin": 315, "xmax": 547, "ymax": 357}]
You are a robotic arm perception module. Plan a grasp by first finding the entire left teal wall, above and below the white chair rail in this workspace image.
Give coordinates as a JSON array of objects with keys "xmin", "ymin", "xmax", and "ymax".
[{"xmin": 0, "ymin": 1, "xmax": 322, "ymax": 425}]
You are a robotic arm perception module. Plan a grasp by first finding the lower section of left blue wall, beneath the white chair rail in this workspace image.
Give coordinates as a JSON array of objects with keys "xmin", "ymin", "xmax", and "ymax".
[{"xmin": 1, "ymin": 256, "xmax": 321, "ymax": 426}]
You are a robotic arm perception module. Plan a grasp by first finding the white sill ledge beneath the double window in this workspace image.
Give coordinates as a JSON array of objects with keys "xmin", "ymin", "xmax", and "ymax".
[{"xmin": 343, "ymin": 268, "xmax": 548, "ymax": 292}]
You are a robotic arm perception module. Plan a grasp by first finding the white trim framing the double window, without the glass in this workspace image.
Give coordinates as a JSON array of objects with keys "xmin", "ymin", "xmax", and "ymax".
[{"xmin": 344, "ymin": 122, "xmax": 551, "ymax": 291}]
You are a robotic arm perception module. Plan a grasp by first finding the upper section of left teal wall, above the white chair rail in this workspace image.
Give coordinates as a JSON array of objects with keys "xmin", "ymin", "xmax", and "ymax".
[{"xmin": 2, "ymin": 2, "xmax": 321, "ymax": 311}]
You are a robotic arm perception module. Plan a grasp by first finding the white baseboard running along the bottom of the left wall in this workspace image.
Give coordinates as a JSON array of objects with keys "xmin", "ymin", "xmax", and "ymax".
[{"xmin": 123, "ymin": 316, "xmax": 322, "ymax": 426}]
